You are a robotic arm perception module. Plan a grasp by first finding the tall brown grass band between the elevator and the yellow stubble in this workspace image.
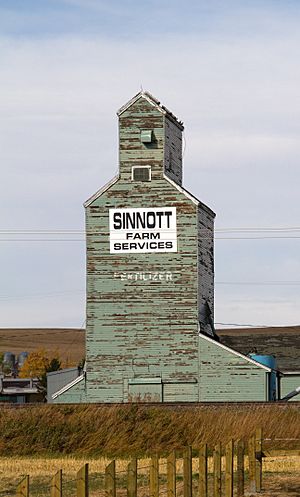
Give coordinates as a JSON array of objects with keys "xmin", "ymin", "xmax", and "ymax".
[{"xmin": 0, "ymin": 404, "xmax": 300, "ymax": 457}]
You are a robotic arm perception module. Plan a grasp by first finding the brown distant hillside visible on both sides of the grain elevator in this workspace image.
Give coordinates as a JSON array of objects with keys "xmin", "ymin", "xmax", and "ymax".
[{"xmin": 0, "ymin": 326, "xmax": 300, "ymax": 371}]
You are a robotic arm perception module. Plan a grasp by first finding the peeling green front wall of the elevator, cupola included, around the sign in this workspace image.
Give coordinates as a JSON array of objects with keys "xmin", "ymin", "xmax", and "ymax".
[{"xmin": 86, "ymin": 94, "xmax": 214, "ymax": 402}]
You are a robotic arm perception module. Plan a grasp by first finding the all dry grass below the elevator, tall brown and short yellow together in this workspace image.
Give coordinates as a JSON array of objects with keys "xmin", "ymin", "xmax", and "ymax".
[{"xmin": 0, "ymin": 405, "xmax": 300, "ymax": 497}]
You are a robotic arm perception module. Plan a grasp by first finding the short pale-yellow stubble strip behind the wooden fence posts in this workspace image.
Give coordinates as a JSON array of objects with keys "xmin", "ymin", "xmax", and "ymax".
[{"xmin": 0, "ymin": 456, "xmax": 300, "ymax": 497}]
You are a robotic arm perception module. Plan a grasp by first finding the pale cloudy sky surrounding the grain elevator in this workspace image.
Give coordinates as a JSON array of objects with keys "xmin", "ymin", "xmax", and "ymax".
[{"xmin": 0, "ymin": 0, "xmax": 300, "ymax": 327}]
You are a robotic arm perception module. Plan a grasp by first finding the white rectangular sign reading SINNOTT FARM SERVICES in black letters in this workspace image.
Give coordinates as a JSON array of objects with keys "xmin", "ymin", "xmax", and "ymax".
[{"xmin": 109, "ymin": 207, "xmax": 177, "ymax": 254}]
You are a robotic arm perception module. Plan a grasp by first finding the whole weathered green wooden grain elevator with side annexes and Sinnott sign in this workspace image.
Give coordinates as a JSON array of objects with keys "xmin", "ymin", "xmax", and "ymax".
[{"xmin": 52, "ymin": 91, "xmax": 272, "ymax": 403}]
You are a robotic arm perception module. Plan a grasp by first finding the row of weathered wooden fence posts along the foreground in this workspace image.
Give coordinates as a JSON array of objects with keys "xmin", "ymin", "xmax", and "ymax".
[{"xmin": 12, "ymin": 429, "xmax": 300, "ymax": 497}]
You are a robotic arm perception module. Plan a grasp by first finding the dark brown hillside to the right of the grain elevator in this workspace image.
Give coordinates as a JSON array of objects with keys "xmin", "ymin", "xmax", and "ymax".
[{"xmin": 217, "ymin": 326, "xmax": 300, "ymax": 371}]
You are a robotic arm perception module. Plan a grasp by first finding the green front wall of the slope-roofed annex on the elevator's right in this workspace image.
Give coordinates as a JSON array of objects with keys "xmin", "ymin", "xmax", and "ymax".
[{"xmin": 199, "ymin": 335, "xmax": 268, "ymax": 402}]
